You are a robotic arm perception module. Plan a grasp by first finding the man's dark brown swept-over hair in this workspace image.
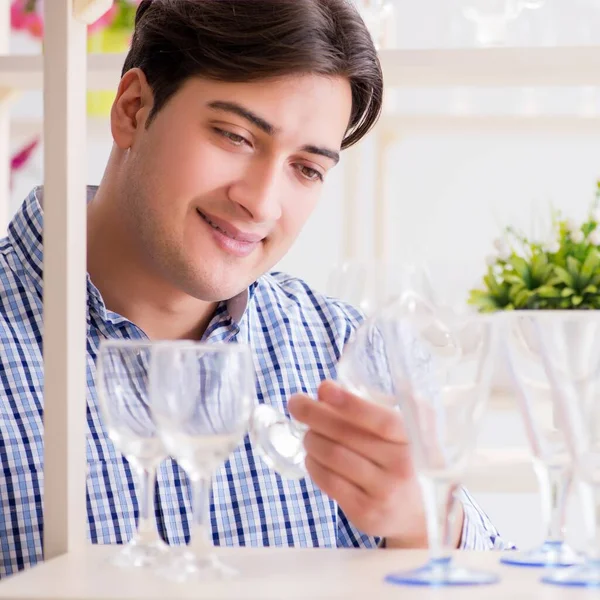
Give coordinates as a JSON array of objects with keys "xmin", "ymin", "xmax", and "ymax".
[{"xmin": 123, "ymin": 0, "xmax": 383, "ymax": 148}]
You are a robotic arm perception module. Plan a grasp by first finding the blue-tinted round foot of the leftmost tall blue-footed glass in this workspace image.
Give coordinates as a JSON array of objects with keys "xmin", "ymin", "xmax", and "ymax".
[{"xmin": 385, "ymin": 558, "xmax": 500, "ymax": 587}]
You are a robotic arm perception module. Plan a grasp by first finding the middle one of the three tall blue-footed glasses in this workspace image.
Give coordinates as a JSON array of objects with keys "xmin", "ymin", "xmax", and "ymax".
[{"xmin": 501, "ymin": 311, "xmax": 581, "ymax": 567}]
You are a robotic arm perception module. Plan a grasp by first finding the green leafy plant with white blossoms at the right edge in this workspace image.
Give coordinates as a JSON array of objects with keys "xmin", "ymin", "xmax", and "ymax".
[{"xmin": 468, "ymin": 182, "xmax": 600, "ymax": 312}]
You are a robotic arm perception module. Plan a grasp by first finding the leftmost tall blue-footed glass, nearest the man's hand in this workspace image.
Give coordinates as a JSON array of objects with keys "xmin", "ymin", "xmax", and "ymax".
[{"xmin": 378, "ymin": 292, "xmax": 499, "ymax": 586}]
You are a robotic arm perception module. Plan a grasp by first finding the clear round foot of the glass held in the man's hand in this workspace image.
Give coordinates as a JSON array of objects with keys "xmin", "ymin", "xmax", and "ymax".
[{"xmin": 250, "ymin": 404, "xmax": 306, "ymax": 479}]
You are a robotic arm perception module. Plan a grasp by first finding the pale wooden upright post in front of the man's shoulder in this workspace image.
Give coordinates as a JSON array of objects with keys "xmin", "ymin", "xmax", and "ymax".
[{"xmin": 44, "ymin": 0, "xmax": 87, "ymax": 560}]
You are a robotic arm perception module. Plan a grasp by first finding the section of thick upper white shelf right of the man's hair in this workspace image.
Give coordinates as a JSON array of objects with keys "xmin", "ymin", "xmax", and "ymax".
[{"xmin": 381, "ymin": 46, "xmax": 600, "ymax": 87}]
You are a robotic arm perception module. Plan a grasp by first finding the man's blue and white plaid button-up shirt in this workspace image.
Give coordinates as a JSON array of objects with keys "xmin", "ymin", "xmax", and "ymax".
[{"xmin": 0, "ymin": 188, "xmax": 504, "ymax": 576}]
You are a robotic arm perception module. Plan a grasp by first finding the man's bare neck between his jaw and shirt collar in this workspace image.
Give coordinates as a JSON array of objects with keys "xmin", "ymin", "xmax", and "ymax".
[{"xmin": 87, "ymin": 188, "xmax": 216, "ymax": 340}]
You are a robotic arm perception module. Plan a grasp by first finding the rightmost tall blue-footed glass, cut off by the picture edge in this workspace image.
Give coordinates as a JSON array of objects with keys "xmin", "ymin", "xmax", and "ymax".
[{"xmin": 516, "ymin": 310, "xmax": 600, "ymax": 588}]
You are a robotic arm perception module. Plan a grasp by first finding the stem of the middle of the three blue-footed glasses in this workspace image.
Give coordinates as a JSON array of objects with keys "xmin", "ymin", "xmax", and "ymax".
[{"xmin": 535, "ymin": 464, "xmax": 573, "ymax": 542}]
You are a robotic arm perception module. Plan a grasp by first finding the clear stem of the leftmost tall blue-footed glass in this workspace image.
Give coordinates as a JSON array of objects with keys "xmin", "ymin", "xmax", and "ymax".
[{"xmin": 419, "ymin": 475, "xmax": 457, "ymax": 562}]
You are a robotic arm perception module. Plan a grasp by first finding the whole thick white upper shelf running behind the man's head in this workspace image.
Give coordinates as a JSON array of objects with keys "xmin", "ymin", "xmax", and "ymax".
[{"xmin": 0, "ymin": 46, "xmax": 600, "ymax": 90}]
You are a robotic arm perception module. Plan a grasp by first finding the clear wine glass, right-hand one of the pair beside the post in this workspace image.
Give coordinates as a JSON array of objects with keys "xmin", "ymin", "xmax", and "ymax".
[{"xmin": 150, "ymin": 342, "xmax": 255, "ymax": 581}]
